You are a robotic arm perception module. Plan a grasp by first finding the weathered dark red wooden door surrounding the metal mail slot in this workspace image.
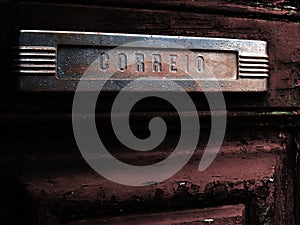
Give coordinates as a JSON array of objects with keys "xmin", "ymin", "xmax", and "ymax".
[{"xmin": 0, "ymin": 0, "xmax": 300, "ymax": 225}]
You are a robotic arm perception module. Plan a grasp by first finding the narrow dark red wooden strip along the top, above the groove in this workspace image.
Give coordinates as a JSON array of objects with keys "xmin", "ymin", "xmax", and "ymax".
[{"xmin": 4, "ymin": 0, "xmax": 299, "ymax": 18}]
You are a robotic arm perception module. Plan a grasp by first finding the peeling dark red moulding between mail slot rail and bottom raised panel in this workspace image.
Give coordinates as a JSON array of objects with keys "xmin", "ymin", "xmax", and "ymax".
[{"xmin": 0, "ymin": 126, "xmax": 284, "ymax": 225}]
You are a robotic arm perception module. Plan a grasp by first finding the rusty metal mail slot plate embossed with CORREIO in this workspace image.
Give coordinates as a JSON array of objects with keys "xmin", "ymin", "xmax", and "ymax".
[{"xmin": 13, "ymin": 30, "xmax": 269, "ymax": 92}]
